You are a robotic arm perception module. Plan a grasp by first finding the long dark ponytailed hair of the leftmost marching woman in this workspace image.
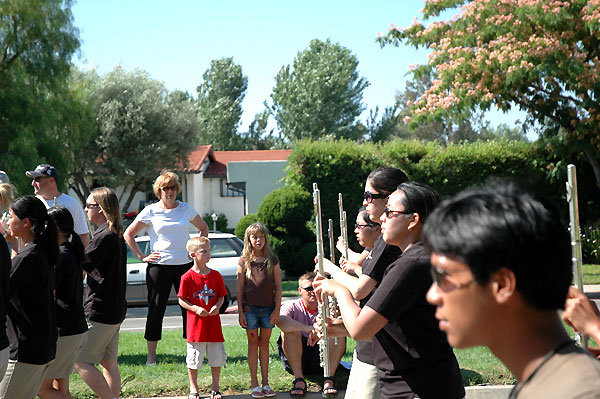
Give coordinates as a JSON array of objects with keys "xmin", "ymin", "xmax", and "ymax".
[{"xmin": 10, "ymin": 195, "xmax": 59, "ymax": 265}]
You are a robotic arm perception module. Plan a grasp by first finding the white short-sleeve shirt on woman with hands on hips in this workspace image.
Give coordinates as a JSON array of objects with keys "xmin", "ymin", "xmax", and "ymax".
[{"xmin": 135, "ymin": 201, "xmax": 198, "ymax": 265}]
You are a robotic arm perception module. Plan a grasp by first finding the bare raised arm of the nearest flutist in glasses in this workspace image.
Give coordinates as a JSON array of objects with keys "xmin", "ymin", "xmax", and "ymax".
[{"xmin": 313, "ymin": 276, "xmax": 388, "ymax": 341}]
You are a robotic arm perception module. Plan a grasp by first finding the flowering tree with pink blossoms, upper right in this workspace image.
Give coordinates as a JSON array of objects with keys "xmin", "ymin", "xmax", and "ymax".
[{"xmin": 378, "ymin": 0, "xmax": 600, "ymax": 191}]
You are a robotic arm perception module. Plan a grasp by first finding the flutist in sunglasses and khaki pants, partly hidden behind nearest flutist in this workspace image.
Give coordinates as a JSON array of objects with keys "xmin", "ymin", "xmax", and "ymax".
[{"xmin": 316, "ymin": 168, "xmax": 408, "ymax": 398}]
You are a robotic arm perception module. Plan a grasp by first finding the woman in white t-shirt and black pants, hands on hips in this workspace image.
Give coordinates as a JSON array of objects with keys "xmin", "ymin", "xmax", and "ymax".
[{"xmin": 124, "ymin": 170, "xmax": 208, "ymax": 366}]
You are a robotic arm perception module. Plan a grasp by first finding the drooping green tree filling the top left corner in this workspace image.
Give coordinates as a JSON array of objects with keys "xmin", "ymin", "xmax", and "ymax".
[{"xmin": 0, "ymin": 0, "xmax": 79, "ymax": 194}]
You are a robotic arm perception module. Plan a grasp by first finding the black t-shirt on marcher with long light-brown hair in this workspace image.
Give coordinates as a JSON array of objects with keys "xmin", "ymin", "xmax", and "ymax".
[{"xmin": 83, "ymin": 225, "xmax": 127, "ymax": 324}]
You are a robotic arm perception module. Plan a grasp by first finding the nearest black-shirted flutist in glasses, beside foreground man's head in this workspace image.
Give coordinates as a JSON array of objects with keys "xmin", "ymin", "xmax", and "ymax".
[{"xmin": 313, "ymin": 182, "xmax": 465, "ymax": 399}]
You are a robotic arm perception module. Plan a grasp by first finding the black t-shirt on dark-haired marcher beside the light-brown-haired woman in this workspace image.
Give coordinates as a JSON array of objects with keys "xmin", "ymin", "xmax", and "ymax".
[{"xmin": 54, "ymin": 241, "xmax": 87, "ymax": 337}]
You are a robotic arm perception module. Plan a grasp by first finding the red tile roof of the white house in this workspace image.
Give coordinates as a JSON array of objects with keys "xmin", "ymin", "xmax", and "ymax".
[{"xmin": 183, "ymin": 145, "xmax": 292, "ymax": 176}]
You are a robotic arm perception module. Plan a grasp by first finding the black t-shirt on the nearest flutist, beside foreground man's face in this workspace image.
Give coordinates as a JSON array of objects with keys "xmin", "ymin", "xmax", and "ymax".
[{"xmin": 366, "ymin": 242, "xmax": 465, "ymax": 399}]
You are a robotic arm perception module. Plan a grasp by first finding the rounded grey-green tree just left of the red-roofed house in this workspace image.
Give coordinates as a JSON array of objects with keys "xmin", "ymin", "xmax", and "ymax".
[{"xmin": 75, "ymin": 67, "xmax": 198, "ymax": 209}]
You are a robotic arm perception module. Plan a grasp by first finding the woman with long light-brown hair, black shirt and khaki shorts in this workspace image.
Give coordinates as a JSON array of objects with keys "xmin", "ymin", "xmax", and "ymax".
[{"xmin": 75, "ymin": 187, "xmax": 127, "ymax": 399}]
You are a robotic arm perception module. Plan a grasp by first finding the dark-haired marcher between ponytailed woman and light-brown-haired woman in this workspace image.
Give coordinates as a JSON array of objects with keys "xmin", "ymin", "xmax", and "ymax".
[{"xmin": 38, "ymin": 206, "xmax": 87, "ymax": 399}]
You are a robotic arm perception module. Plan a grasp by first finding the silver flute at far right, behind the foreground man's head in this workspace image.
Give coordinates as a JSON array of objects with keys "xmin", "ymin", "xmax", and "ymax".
[{"xmin": 567, "ymin": 165, "xmax": 588, "ymax": 348}]
